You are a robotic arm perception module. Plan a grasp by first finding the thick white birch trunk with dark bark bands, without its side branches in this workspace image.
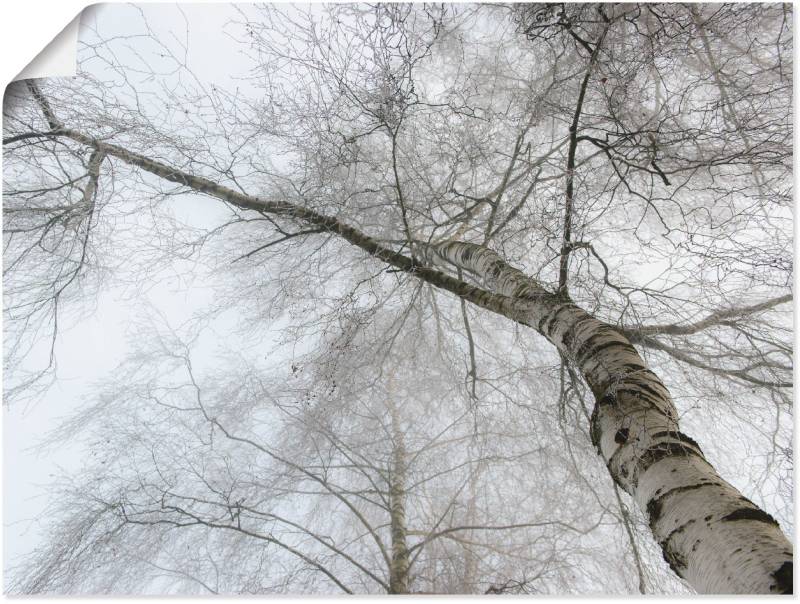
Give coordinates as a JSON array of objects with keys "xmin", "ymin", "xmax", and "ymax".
[{"xmin": 420, "ymin": 242, "xmax": 792, "ymax": 593}]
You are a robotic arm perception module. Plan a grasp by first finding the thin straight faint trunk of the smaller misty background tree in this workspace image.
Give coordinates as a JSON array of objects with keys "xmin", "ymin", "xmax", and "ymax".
[{"xmin": 389, "ymin": 401, "xmax": 408, "ymax": 594}]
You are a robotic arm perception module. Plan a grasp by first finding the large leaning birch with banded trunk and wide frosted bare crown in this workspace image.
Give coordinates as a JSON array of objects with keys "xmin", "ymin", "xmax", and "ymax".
[{"xmin": 4, "ymin": 4, "xmax": 792, "ymax": 593}]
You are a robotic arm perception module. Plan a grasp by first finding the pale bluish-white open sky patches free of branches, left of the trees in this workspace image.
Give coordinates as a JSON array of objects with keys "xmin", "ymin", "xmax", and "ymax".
[{"xmin": 3, "ymin": 4, "xmax": 247, "ymax": 567}]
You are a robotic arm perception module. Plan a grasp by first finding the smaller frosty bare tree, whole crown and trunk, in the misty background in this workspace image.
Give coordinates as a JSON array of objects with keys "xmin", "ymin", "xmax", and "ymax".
[{"xmin": 7, "ymin": 316, "xmax": 620, "ymax": 594}]
